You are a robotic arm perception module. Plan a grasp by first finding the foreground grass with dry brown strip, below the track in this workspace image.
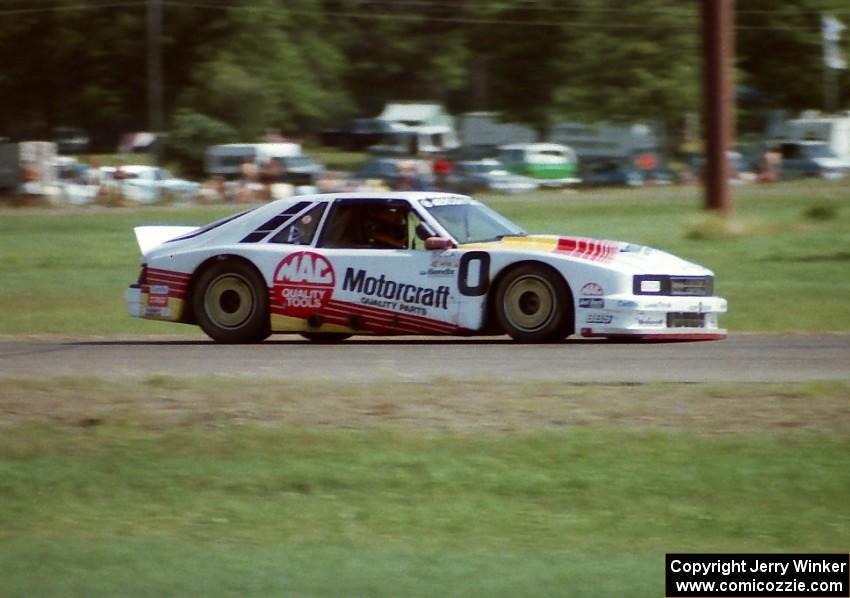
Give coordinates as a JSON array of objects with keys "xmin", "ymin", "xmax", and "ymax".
[{"xmin": 0, "ymin": 377, "xmax": 850, "ymax": 596}]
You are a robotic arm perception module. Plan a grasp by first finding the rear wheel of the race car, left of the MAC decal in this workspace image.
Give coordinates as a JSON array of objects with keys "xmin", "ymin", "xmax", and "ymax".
[{"xmin": 192, "ymin": 260, "xmax": 271, "ymax": 343}]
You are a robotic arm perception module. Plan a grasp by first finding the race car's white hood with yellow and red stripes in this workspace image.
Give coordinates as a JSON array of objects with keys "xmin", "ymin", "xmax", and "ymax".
[{"xmin": 461, "ymin": 235, "xmax": 711, "ymax": 276}]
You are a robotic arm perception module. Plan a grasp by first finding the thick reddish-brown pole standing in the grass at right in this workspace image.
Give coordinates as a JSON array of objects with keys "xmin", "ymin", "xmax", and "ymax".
[{"xmin": 702, "ymin": 0, "xmax": 735, "ymax": 216}]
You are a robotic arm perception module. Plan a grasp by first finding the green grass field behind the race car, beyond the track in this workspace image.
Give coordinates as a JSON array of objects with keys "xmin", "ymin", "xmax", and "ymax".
[{"xmin": 0, "ymin": 183, "xmax": 850, "ymax": 335}]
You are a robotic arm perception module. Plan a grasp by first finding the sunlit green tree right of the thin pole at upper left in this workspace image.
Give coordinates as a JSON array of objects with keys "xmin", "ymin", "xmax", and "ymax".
[{"xmin": 178, "ymin": 0, "xmax": 348, "ymax": 139}]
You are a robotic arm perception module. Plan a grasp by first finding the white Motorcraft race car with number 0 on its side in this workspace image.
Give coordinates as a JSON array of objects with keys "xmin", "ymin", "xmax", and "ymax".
[{"xmin": 126, "ymin": 192, "xmax": 726, "ymax": 343}]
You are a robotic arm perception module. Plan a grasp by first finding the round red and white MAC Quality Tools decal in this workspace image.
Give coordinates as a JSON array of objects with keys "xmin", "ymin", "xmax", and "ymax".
[{"xmin": 272, "ymin": 251, "xmax": 336, "ymax": 318}]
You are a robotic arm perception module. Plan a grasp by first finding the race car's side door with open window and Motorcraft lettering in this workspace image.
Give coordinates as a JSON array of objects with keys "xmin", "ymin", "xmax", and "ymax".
[{"xmin": 316, "ymin": 198, "xmax": 459, "ymax": 334}]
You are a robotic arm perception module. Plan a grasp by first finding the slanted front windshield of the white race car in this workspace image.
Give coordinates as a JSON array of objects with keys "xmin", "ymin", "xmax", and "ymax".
[{"xmin": 422, "ymin": 197, "xmax": 526, "ymax": 243}]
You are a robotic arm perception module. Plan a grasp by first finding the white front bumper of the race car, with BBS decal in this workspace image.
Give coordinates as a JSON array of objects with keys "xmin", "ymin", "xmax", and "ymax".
[{"xmin": 576, "ymin": 295, "xmax": 727, "ymax": 340}]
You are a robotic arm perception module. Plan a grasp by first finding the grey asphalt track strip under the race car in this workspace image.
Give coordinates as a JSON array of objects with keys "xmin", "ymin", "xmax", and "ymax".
[{"xmin": 0, "ymin": 334, "xmax": 850, "ymax": 383}]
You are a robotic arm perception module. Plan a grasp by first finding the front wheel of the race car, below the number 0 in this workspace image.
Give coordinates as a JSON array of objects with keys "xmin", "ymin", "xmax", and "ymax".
[{"xmin": 495, "ymin": 264, "xmax": 574, "ymax": 343}]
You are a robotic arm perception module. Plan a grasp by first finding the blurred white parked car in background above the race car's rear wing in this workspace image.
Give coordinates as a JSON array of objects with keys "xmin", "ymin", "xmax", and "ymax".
[{"xmin": 100, "ymin": 164, "xmax": 201, "ymax": 203}]
